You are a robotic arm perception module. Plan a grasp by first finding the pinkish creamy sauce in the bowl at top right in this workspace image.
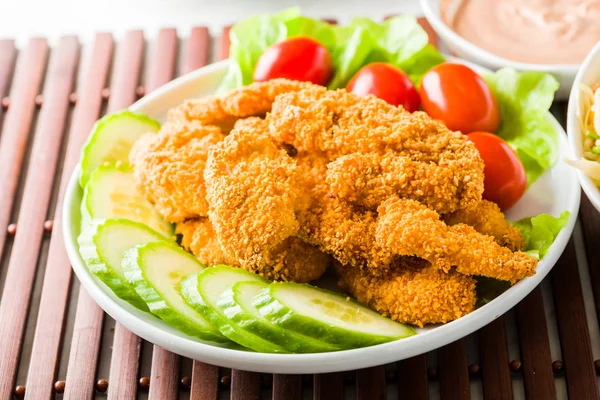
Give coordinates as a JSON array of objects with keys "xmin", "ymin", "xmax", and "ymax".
[{"xmin": 440, "ymin": 0, "xmax": 600, "ymax": 64}]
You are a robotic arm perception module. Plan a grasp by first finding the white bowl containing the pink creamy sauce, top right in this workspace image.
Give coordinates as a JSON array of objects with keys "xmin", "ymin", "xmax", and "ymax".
[{"xmin": 419, "ymin": 0, "xmax": 580, "ymax": 100}]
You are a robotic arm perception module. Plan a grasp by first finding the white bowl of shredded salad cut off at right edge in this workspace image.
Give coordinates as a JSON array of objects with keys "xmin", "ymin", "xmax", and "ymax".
[{"xmin": 567, "ymin": 42, "xmax": 600, "ymax": 211}]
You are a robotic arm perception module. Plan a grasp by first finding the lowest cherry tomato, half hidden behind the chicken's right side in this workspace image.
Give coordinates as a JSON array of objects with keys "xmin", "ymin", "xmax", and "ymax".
[{"xmin": 467, "ymin": 132, "xmax": 527, "ymax": 209}]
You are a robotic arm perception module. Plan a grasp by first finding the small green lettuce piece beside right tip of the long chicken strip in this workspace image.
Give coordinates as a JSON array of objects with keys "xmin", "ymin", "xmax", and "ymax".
[{"xmin": 512, "ymin": 211, "xmax": 570, "ymax": 260}]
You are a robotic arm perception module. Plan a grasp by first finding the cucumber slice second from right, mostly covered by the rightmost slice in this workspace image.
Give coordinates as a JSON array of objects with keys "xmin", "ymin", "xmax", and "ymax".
[{"xmin": 217, "ymin": 281, "xmax": 340, "ymax": 353}]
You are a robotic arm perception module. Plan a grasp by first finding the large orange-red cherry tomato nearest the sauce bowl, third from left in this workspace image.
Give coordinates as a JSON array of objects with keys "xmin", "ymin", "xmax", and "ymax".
[{"xmin": 420, "ymin": 63, "xmax": 500, "ymax": 133}]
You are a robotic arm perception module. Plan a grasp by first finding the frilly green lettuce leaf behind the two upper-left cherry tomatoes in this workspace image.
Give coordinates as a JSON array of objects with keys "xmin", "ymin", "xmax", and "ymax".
[{"xmin": 218, "ymin": 8, "xmax": 444, "ymax": 93}]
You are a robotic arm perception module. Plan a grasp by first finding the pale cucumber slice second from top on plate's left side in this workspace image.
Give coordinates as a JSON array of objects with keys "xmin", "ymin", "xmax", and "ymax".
[{"xmin": 81, "ymin": 164, "xmax": 173, "ymax": 236}]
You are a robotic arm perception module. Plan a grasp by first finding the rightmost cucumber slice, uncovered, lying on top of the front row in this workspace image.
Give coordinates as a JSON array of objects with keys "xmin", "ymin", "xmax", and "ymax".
[{"xmin": 254, "ymin": 282, "xmax": 416, "ymax": 349}]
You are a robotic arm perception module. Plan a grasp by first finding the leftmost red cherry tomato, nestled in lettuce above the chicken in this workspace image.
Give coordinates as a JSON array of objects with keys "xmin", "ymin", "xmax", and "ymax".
[{"xmin": 254, "ymin": 36, "xmax": 333, "ymax": 86}]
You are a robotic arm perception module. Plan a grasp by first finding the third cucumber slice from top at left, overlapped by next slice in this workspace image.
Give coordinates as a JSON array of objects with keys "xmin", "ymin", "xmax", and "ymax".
[{"xmin": 77, "ymin": 219, "xmax": 169, "ymax": 311}]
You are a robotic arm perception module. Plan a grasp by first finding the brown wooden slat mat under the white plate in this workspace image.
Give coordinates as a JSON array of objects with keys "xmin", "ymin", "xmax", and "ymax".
[{"xmin": 0, "ymin": 20, "xmax": 600, "ymax": 400}]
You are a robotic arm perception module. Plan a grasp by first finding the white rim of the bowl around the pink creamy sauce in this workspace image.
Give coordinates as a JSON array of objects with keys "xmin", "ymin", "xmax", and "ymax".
[{"xmin": 420, "ymin": 0, "xmax": 580, "ymax": 70}]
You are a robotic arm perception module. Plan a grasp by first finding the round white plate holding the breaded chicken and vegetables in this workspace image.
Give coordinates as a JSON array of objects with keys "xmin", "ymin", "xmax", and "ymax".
[{"xmin": 63, "ymin": 62, "xmax": 580, "ymax": 374}]
